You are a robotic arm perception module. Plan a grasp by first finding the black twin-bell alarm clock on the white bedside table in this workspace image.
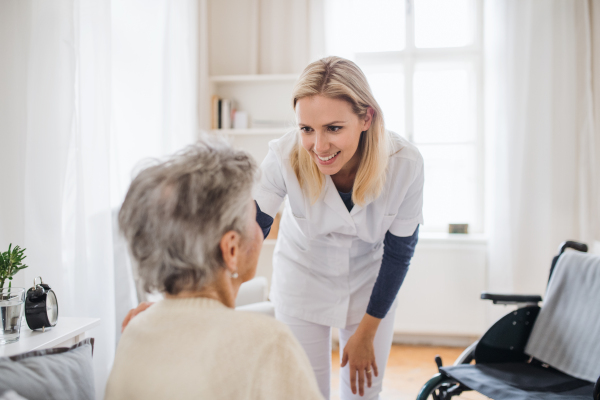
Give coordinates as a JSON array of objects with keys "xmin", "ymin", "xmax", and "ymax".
[{"xmin": 25, "ymin": 276, "xmax": 58, "ymax": 330}]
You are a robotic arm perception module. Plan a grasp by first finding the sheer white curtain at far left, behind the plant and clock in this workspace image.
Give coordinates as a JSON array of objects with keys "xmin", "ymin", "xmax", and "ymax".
[{"xmin": 0, "ymin": 0, "xmax": 115, "ymax": 396}]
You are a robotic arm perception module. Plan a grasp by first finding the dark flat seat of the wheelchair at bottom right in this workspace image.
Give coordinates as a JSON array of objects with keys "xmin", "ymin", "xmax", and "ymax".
[{"xmin": 441, "ymin": 363, "xmax": 594, "ymax": 400}]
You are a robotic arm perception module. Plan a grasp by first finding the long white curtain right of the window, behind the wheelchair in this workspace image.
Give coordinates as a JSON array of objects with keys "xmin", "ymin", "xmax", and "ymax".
[{"xmin": 484, "ymin": 0, "xmax": 600, "ymax": 322}]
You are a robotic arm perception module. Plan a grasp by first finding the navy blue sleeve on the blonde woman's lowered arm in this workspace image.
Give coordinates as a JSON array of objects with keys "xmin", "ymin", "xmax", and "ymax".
[{"xmin": 367, "ymin": 225, "xmax": 419, "ymax": 318}]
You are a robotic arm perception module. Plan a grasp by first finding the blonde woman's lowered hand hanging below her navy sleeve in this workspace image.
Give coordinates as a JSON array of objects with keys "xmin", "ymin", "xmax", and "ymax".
[{"xmin": 341, "ymin": 314, "xmax": 381, "ymax": 396}]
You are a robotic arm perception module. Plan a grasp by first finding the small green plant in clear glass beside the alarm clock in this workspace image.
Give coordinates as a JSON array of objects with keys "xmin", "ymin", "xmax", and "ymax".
[{"xmin": 0, "ymin": 243, "xmax": 27, "ymax": 344}]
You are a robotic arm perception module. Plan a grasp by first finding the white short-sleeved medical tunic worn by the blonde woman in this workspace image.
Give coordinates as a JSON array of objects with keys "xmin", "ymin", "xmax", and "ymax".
[{"xmin": 254, "ymin": 130, "xmax": 423, "ymax": 328}]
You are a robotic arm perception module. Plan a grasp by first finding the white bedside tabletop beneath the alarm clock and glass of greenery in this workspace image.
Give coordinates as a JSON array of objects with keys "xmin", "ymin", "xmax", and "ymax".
[{"xmin": 0, "ymin": 317, "xmax": 100, "ymax": 357}]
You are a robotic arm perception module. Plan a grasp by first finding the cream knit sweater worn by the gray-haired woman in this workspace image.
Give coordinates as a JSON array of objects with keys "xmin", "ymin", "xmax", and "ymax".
[{"xmin": 105, "ymin": 298, "xmax": 322, "ymax": 400}]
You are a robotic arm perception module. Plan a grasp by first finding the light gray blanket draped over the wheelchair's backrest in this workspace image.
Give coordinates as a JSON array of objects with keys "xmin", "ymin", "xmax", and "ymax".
[{"xmin": 525, "ymin": 251, "xmax": 600, "ymax": 382}]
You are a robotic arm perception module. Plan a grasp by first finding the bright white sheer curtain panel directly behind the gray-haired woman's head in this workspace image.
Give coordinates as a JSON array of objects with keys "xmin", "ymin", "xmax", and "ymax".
[{"xmin": 110, "ymin": 0, "xmax": 199, "ymax": 346}]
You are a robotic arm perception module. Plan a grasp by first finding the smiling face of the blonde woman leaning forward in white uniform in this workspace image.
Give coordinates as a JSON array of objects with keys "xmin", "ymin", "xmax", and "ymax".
[{"xmin": 296, "ymin": 95, "xmax": 372, "ymax": 175}]
